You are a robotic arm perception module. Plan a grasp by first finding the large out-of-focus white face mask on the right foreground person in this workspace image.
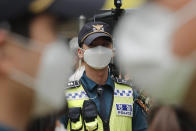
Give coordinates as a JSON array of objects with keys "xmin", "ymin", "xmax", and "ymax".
[{"xmin": 115, "ymin": 3, "xmax": 196, "ymax": 105}]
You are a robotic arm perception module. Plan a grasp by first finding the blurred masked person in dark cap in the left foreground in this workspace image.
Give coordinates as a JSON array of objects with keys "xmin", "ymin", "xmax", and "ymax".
[{"xmin": 0, "ymin": 0, "xmax": 103, "ymax": 131}]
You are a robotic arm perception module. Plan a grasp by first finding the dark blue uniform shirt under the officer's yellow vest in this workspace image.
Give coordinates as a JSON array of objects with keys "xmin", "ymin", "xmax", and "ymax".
[{"xmin": 63, "ymin": 72, "xmax": 147, "ymax": 131}]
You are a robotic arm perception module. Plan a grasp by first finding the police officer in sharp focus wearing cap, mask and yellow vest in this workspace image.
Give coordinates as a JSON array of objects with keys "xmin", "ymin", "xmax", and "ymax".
[{"xmin": 65, "ymin": 22, "xmax": 147, "ymax": 131}]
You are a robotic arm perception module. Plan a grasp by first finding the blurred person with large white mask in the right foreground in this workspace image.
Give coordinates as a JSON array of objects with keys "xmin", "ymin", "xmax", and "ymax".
[{"xmin": 116, "ymin": 0, "xmax": 196, "ymax": 131}]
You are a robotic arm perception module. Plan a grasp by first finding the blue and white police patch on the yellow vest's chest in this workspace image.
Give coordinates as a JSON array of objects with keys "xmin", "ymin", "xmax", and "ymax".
[{"xmin": 116, "ymin": 104, "xmax": 133, "ymax": 117}]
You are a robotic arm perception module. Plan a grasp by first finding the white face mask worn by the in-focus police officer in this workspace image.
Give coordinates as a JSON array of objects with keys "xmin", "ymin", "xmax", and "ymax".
[{"xmin": 84, "ymin": 46, "xmax": 113, "ymax": 69}]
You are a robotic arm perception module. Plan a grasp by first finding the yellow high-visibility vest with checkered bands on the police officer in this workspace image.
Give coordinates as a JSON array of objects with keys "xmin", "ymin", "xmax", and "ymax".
[{"xmin": 65, "ymin": 83, "xmax": 134, "ymax": 131}]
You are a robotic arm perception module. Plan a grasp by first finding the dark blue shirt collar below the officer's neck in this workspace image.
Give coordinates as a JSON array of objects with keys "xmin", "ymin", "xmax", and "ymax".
[{"xmin": 81, "ymin": 72, "xmax": 114, "ymax": 91}]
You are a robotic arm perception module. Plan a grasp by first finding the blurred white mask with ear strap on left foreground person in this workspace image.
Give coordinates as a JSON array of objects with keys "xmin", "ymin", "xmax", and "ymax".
[{"xmin": 10, "ymin": 40, "xmax": 72, "ymax": 117}]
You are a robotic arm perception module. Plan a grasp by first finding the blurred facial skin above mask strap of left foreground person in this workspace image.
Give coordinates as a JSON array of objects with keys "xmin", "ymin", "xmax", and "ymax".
[{"xmin": 0, "ymin": 15, "xmax": 56, "ymax": 91}]
